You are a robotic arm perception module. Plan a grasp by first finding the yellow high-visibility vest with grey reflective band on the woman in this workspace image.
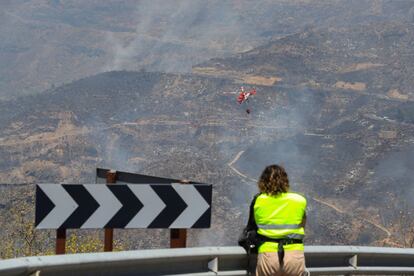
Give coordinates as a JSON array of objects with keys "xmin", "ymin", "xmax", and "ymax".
[{"xmin": 254, "ymin": 192, "xmax": 306, "ymax": 253}]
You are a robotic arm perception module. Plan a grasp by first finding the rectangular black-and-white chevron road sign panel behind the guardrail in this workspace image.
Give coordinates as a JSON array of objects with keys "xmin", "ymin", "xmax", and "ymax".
[{"xmin": 35, "ymin": 183, "xmax": 212, "ymax": 229}]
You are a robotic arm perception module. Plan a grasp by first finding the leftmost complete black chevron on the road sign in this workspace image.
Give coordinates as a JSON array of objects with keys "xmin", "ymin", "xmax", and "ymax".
[{"xmin": 60, "ymin": 185, "xmax": 99, "ymax": 229}]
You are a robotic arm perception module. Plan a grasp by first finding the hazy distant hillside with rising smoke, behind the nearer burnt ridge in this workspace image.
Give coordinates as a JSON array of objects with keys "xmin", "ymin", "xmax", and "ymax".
[{"xmin": 0, "ymin": 0, "xmax": 414, "ymax": 99}]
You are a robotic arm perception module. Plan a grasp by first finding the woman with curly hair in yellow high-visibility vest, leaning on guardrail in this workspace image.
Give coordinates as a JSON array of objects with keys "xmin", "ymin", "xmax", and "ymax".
[{"xmin": 254, "ymin": 165, "xmax": 306, "ymax": 276}]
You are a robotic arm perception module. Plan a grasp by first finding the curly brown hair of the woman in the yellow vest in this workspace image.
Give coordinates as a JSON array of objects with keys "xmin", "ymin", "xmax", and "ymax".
[{"xmin": 257, "ymin": 165, "xmax": 289, "ymax": 195}]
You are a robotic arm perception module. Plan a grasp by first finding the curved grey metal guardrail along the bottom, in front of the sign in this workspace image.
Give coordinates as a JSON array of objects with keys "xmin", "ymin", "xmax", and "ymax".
[{"xmin": 0, "ymin": 246, "xmax": 414, "ymax": 276}]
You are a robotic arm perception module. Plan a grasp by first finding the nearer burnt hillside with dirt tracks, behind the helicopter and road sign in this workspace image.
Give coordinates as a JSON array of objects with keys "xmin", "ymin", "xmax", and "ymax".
[{"xmin": 0, "ymin": 11, "xmax": 414, "ymax": 256}]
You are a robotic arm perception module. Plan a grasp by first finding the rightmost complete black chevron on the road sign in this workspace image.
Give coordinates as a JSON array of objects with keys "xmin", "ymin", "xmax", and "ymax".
[{"xmin": 148, "ymin": 184, "xmax": 187, "ymax": 228}]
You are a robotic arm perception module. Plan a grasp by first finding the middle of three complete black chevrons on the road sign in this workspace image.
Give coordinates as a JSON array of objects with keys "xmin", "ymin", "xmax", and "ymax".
[{"xmin": 105, "ymin": 185, "xmax": 144, "ymax": 228}]
